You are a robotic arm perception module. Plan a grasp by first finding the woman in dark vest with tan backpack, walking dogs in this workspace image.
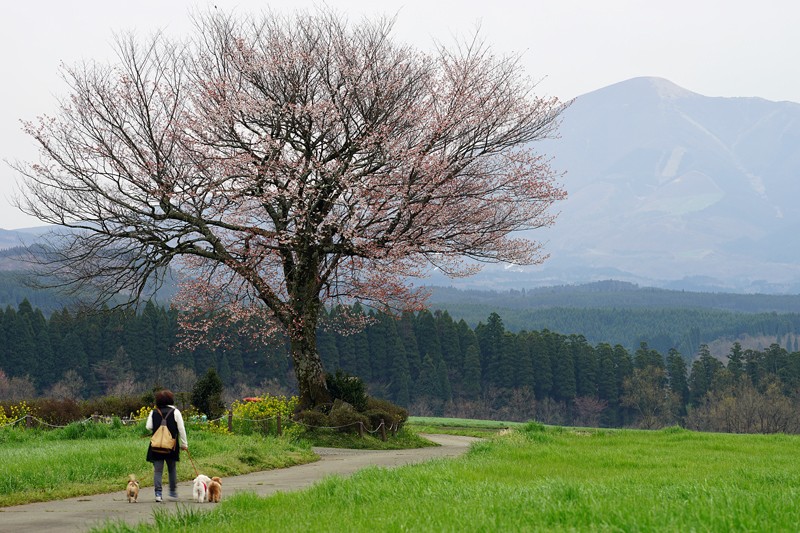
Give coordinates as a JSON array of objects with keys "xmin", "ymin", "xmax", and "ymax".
[{"xmin": 145, "ymin": 389, "xmax": 189, "ymax": 502}]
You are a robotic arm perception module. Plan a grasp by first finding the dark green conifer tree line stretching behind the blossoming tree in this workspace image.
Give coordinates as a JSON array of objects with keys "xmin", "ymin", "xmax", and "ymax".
[{"xmin": 0, "ymin": 301, "xmax": 800, "ymax": 432}]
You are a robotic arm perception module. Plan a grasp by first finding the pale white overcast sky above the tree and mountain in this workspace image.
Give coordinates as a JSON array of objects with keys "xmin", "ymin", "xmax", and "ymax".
[{"xmin": 0, "ymin": 0, "xmax": 800, "ymax": 229}]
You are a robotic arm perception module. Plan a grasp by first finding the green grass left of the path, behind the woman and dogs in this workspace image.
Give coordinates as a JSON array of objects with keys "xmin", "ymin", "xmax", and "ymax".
[{"xmin": 0, "ymin": 424, "xmax": 316, "ymax": 508}]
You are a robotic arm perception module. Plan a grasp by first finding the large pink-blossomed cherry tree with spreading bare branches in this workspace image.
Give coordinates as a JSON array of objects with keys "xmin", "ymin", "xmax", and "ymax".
[{"xmin": 16, "ymin": 10, "xmax": 564, "ymax": 407}]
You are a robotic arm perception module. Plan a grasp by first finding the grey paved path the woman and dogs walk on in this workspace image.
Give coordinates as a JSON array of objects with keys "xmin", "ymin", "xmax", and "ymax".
[{"xmin": 0, "ymin": 435, "xmax": 478, "ymax": 533}]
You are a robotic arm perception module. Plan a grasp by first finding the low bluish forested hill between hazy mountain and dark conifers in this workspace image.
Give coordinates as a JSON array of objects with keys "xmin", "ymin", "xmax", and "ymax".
[{"xmin": 430, "ymin": 281, "xmax": 800, "ymax": 358}]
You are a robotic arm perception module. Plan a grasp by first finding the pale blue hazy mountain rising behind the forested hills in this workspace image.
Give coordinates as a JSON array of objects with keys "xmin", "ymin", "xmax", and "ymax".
[{"xmin": 0, "ymin": 78, "xmax": 800, "ymax": 293}]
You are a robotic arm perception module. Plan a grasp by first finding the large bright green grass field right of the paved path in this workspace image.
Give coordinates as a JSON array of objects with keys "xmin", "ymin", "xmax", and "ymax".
[{"xmin": 95, "ymin": 423, "xmax": 800, "ymax": 532}]
